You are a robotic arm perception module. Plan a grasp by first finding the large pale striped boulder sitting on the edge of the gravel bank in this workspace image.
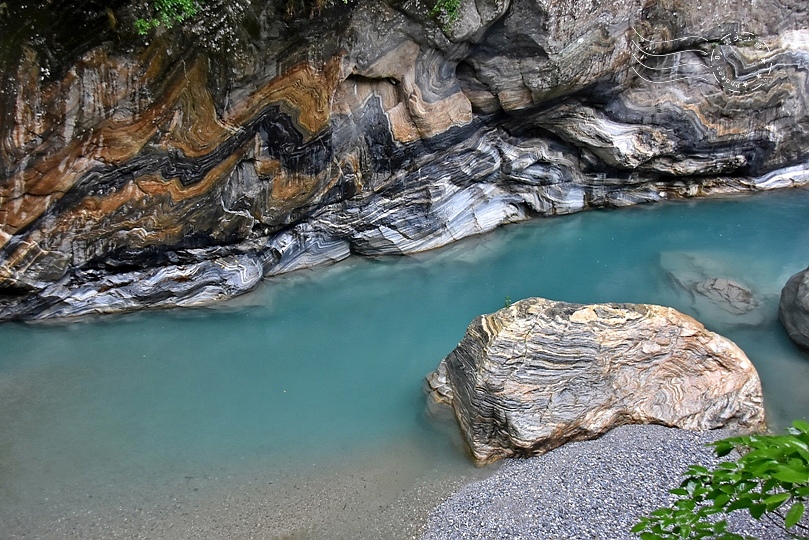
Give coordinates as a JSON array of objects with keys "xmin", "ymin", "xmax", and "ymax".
[{"xmin": 428, "ymin": 298, "xmax": 765, "ymax": 464}]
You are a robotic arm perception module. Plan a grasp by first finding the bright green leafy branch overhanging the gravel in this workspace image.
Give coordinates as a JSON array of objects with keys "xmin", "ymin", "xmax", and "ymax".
[{"xmin": 632, "ymin": 421, "xmax": 809, "ymax": 540}]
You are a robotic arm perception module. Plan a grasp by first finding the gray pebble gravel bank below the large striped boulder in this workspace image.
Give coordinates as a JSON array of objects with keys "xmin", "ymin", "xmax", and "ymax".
[{"xmin": 422, "ymin": 426, "xmax": 788, "ymax": 540}]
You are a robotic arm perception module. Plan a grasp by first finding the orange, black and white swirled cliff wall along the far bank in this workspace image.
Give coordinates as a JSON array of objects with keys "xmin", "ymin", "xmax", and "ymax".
[{"xmin": 0, "ymin": 0, "xmax": 809, "ymax": 320}]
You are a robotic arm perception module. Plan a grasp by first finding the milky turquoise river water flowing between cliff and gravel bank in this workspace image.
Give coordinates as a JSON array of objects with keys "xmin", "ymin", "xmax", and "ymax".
[{"xmin": 0, "ymin": 190, "xmax": 809, "ymax": 538}]
